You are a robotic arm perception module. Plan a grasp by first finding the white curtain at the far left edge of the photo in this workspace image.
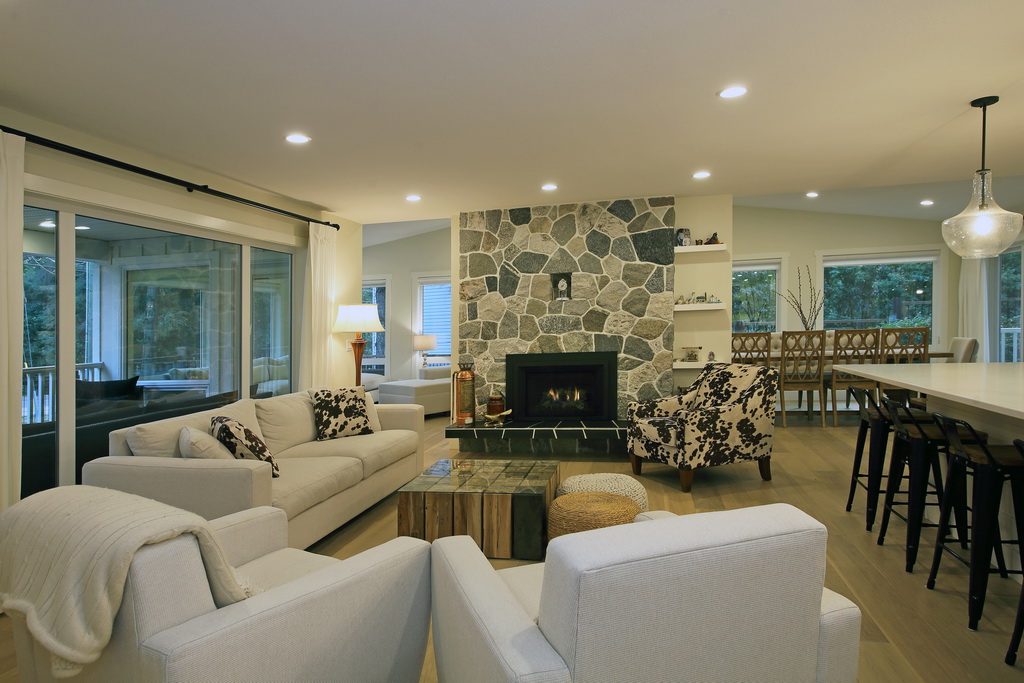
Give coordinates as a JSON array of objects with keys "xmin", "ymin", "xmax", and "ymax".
[{"xmin": 0, "ymin": 133, "xmax": 25, "ymax": 512}]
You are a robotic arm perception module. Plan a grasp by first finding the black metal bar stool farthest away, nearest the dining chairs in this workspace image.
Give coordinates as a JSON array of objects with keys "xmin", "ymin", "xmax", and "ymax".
[{"xmin": 846, "ymin": 386, "xmax": 932, "ymax": 531}]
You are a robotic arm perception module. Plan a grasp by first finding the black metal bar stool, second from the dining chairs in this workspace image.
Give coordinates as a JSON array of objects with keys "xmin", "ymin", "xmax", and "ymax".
[{"xmin": 879, "ymin": 397, "xmax": 961, "ymax": 572}]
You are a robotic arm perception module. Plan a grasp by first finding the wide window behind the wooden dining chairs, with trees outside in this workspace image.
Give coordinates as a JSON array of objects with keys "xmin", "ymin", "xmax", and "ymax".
[{"xmin": 823, "ymin": 253, "xmax": 939, "ymax": 344}]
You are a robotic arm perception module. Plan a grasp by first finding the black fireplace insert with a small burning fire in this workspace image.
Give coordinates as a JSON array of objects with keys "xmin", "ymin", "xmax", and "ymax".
[{"xmin": 505, "ymin": 351, "xmax": 618, "ymax": 422}]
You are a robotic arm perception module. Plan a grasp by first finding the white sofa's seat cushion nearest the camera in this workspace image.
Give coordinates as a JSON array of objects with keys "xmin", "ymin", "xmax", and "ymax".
[{"xmin": 270, "ymin": 458, "xmax": 362, "ymax": 519}]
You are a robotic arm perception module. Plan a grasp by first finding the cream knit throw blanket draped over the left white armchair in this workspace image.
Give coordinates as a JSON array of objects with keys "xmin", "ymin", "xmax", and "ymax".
[{"xmin": 0, "ymin": 486, "xmax": 248, "ymax": 678}]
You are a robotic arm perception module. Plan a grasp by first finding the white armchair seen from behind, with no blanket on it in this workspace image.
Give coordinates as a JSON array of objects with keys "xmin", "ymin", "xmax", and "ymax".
[{"xmin": 431, "ymin": 504, "xmax": 860, "ymax": 683}]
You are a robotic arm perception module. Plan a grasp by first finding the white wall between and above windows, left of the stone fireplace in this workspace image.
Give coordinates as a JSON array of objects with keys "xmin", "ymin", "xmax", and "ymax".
[{"xmin": 364, "ymin": 228, "xmax": 452, "ymax": 380}]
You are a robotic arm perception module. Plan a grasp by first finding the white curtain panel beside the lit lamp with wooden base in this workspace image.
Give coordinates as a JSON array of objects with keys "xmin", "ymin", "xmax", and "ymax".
[{"xmin": 306, "ymin": 223, "xmax": 338, "ymax": 384}]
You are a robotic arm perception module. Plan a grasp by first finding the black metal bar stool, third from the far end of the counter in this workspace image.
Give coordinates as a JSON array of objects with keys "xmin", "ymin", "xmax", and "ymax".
[{"xmin": 928, "ymin": 414, "xmax": 1024, "ymax": 634}]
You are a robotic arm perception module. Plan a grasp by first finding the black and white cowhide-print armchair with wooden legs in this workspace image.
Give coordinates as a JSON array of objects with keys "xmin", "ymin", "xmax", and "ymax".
[{"xmin": 627, "ymin": 362, "xmax": 778, "ymax": 492}]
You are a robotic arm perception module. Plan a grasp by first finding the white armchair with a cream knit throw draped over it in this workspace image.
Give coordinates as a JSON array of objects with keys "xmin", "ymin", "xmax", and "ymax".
[{"xmin": 11, "ymin": 507, "xmax": 430, "ymax": 683}]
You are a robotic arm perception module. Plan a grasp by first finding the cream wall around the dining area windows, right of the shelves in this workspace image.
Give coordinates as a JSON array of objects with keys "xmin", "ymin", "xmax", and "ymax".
[{"xmin": 732, "ymin": 206, "xmax": 961, "ymax": 348}]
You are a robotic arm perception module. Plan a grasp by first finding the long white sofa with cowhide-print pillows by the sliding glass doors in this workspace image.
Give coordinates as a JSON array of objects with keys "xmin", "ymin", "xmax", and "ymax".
[{"xmin": 82, "ymin": 392, "xmax": 423, "ymax": 548}]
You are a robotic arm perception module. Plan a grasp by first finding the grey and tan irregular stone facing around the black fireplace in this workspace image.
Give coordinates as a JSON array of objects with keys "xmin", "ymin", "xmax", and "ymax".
[{"xmin": 458, "ymin": 192, "xmax": 676, "ymax": 419}]
